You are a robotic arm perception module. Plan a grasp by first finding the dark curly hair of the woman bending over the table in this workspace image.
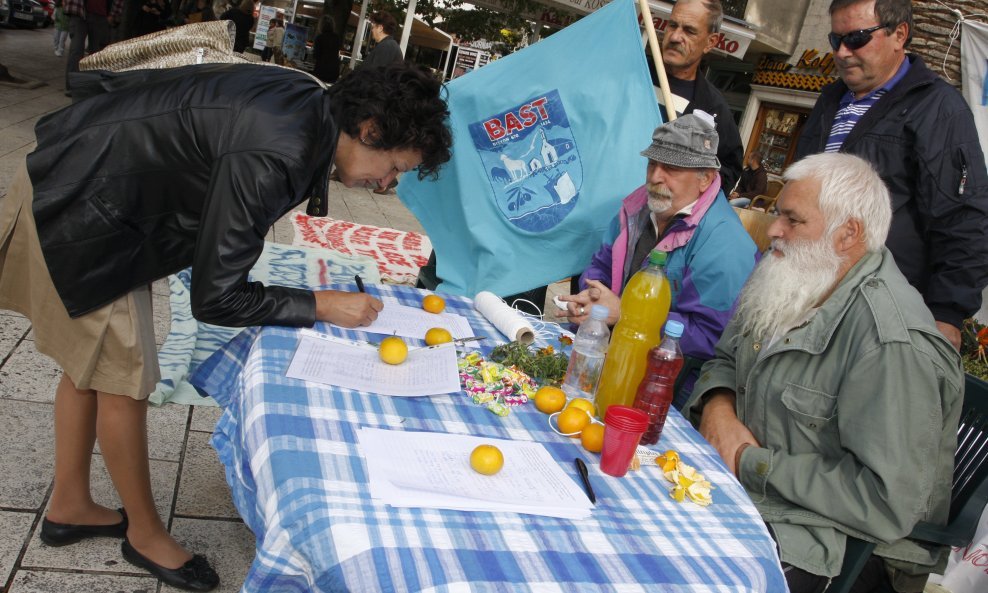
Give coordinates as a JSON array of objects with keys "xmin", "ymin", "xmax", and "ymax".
[{"xmin": 329, "ymin": 63, "xmax": 453, "ymax": 179}]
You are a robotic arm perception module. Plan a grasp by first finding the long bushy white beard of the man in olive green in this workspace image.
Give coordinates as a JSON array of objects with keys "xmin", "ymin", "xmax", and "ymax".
[{"xmin": 736, "ymin": 236, "xmax": 842, "ymax": 339}]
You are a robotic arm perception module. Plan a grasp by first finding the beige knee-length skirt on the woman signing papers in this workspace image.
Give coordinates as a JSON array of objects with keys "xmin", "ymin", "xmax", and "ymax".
[{"xmin": 0, "ymin": 165, "xmax": 161, "ymax": 399}]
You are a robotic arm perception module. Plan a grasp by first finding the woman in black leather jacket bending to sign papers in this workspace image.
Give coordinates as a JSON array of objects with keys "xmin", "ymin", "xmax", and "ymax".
[{"xmin": 0, "ymin": 64, "xmax": 452, "ymax": 591}]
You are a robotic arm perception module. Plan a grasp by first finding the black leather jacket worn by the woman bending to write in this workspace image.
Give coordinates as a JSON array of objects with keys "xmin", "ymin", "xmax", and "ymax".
[{"xmin": 27, "ymin": 64, "xmax": 338, "ymax": 326}]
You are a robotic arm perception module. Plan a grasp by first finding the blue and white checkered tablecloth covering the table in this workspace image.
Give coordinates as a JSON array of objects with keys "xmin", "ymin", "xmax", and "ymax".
[{"xmin": 191, "ymin": 286, "xmax": 786, "ymax": 593}]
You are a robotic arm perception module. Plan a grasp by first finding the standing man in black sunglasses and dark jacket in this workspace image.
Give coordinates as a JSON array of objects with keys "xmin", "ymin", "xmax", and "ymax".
[{"xmin": 795, "ymin": 0, "xmax": 988, "ymax": 348}]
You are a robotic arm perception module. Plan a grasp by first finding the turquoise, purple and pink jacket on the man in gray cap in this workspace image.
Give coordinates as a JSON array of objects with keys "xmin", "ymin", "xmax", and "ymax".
[{"xmin": 580, "ymin": 176, "xmax": 760, "ymax": 407}]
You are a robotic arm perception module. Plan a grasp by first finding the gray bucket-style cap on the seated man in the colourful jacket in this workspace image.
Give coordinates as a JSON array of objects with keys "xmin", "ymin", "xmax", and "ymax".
[{"xmin": 641, "ymin": 111, "xmax": 720, "ymax": 169}]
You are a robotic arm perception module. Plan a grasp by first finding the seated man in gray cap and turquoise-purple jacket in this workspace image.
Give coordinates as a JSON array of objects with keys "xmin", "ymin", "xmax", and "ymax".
[{"xmin": 560, "ymin": 111, "xmax": 759, "ymax": 408}]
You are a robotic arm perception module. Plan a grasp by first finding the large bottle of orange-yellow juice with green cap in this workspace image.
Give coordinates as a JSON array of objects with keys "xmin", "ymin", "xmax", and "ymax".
[{"xmin": 597, "ymin": 249, "xmax": 672, "ymax": 418}]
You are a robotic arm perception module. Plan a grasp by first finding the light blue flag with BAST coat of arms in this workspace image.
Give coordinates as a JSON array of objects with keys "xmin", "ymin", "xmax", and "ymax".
[{"xmin": 398, "ymin": 0, "xmax": 661, "ymax": 297}]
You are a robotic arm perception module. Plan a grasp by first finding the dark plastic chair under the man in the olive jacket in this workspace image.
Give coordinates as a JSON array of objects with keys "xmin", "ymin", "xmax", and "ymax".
[{"xmin": 827, "ymin": 375, "xmax": 988, "ymax": 593}]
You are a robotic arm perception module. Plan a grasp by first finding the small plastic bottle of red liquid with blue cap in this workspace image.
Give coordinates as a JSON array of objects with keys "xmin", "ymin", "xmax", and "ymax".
[{"xmin": 635, "ymin": 320, "xmax": 683, "ymax": 445}]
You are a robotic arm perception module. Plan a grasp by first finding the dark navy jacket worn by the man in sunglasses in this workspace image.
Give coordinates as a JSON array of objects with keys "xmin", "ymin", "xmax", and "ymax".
[{"xmin": 796, "ymin": 56, "xmax": 988, "ymax": 327}]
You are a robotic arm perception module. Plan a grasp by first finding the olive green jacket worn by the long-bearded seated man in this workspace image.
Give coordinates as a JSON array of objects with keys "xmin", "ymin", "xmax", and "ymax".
[{"xmin": 685, "ymin": 248, "xmax": 964, "ymax": 590}]
